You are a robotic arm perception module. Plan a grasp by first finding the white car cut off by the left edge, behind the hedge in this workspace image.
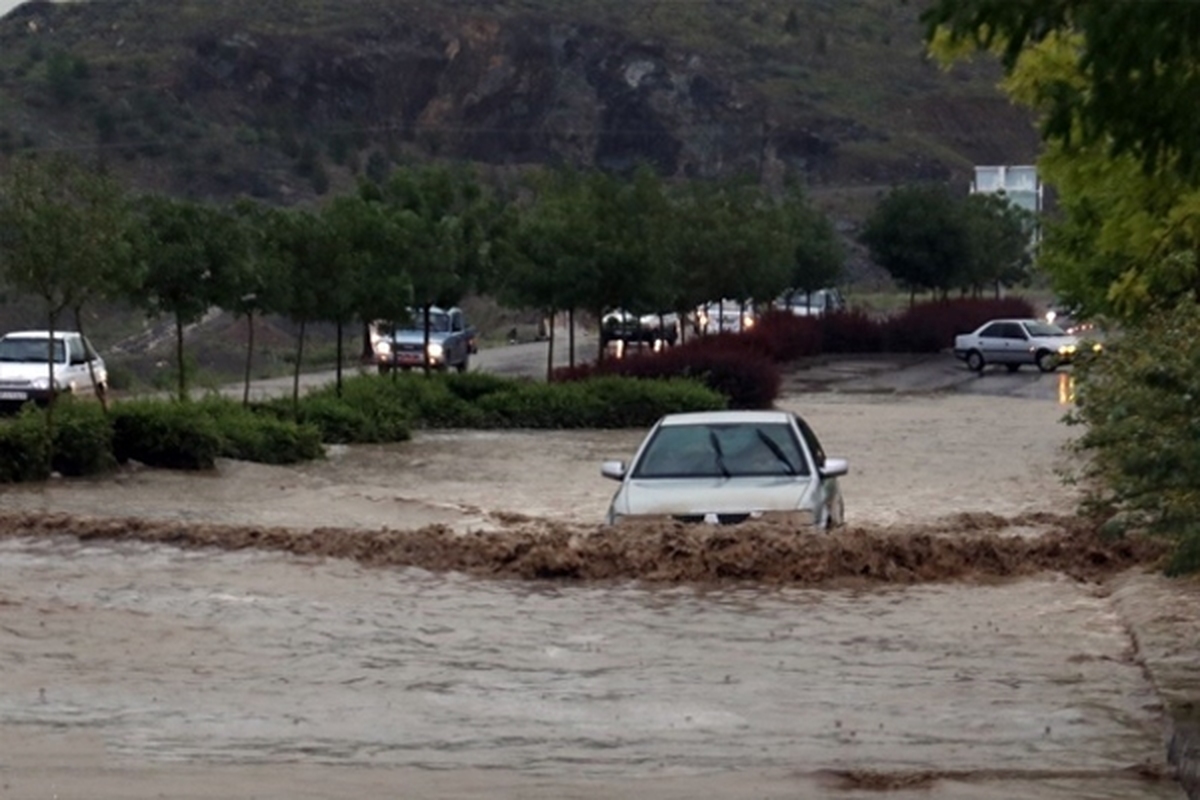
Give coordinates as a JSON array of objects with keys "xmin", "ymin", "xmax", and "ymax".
[{"xmin": 0, "ymin": 331, "xmax": 108, "ymax": 405}]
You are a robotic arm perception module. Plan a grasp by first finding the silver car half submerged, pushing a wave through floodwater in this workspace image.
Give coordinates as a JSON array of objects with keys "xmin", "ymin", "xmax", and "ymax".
[{"xmin": 600, "ymin": 411, "xmax": 850, "ymax": 528}]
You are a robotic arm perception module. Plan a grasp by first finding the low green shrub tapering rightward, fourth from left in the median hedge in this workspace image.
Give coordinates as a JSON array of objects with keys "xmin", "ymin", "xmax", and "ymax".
[{"xmin": 196, "ymin": 398, "xmax": 325, "ymax": 464}]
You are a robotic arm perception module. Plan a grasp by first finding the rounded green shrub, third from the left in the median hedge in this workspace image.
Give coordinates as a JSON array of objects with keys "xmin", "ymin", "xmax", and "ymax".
[{"xmin": 109, "ymin": 401, "xmax": 222, "ymax": 469}]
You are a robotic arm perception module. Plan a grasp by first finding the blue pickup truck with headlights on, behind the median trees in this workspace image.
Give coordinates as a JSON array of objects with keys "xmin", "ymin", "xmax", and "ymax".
[{"xmin": 368, "ymin": 306, "xmax": 478, "ymax": 374}]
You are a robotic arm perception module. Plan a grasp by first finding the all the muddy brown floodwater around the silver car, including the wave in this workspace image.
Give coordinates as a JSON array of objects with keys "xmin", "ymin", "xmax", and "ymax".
[{"xmin": 0, "ymin": 386, "xmax": 1195, "ymax": 799}]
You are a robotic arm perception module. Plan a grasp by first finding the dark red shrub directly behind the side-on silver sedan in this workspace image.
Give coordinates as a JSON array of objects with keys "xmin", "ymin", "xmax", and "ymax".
[{"xmin": 883, "ymin": 297, "xmax": 1034, "ymax": 353}]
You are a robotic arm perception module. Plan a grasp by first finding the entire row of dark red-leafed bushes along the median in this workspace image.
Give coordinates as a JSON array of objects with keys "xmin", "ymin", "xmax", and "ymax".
[{"xmin": 556, "ymin": 297, "xmax": 1033, "ymax": 408}]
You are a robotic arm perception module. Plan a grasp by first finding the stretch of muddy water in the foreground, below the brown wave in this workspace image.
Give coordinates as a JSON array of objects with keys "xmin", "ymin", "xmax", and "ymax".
[{"xmin": 0, "ymin": 539, "xmax": 1180, "ymax": 799}]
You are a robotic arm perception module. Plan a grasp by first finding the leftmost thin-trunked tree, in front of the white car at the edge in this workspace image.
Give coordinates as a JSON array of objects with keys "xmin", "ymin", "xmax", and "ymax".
[{"xmin": 0, "ymin": 156, "xmax": 131, "ymax": 427}]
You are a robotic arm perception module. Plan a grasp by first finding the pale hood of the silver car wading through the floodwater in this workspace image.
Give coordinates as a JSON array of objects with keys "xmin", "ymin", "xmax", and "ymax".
[{"xmin": 616, "ymin": 476, "xmax": 812, "ymax": 516}]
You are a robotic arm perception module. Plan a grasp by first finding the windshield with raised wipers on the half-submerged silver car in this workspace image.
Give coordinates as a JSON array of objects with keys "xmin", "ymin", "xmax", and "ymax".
[{"xmin": 634, "ymin": 422, "xmax": 809, "ymax": 479}]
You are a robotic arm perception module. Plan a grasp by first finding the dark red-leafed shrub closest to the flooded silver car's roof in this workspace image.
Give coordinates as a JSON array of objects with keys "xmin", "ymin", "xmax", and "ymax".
[{"xmin": 554, "ymin": 333, "xmax": 782, "ymax": 408}]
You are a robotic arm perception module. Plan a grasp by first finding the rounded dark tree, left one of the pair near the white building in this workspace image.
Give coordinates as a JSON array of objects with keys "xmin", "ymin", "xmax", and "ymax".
[{"xmin": 862, "ymin": 184, "xmax": 971, "ymax": 300}]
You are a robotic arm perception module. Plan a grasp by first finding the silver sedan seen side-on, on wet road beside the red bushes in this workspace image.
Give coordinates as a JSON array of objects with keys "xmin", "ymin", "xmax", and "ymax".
[{"xmin": 954, "ymin": 319, "xmax": 1080, "ymax": 372}]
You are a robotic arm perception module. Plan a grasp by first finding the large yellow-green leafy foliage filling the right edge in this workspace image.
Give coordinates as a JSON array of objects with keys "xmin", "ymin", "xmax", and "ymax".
[{"xmin": 925, "ymin": 0, "xmax": 1200, "ymax": 571}]
